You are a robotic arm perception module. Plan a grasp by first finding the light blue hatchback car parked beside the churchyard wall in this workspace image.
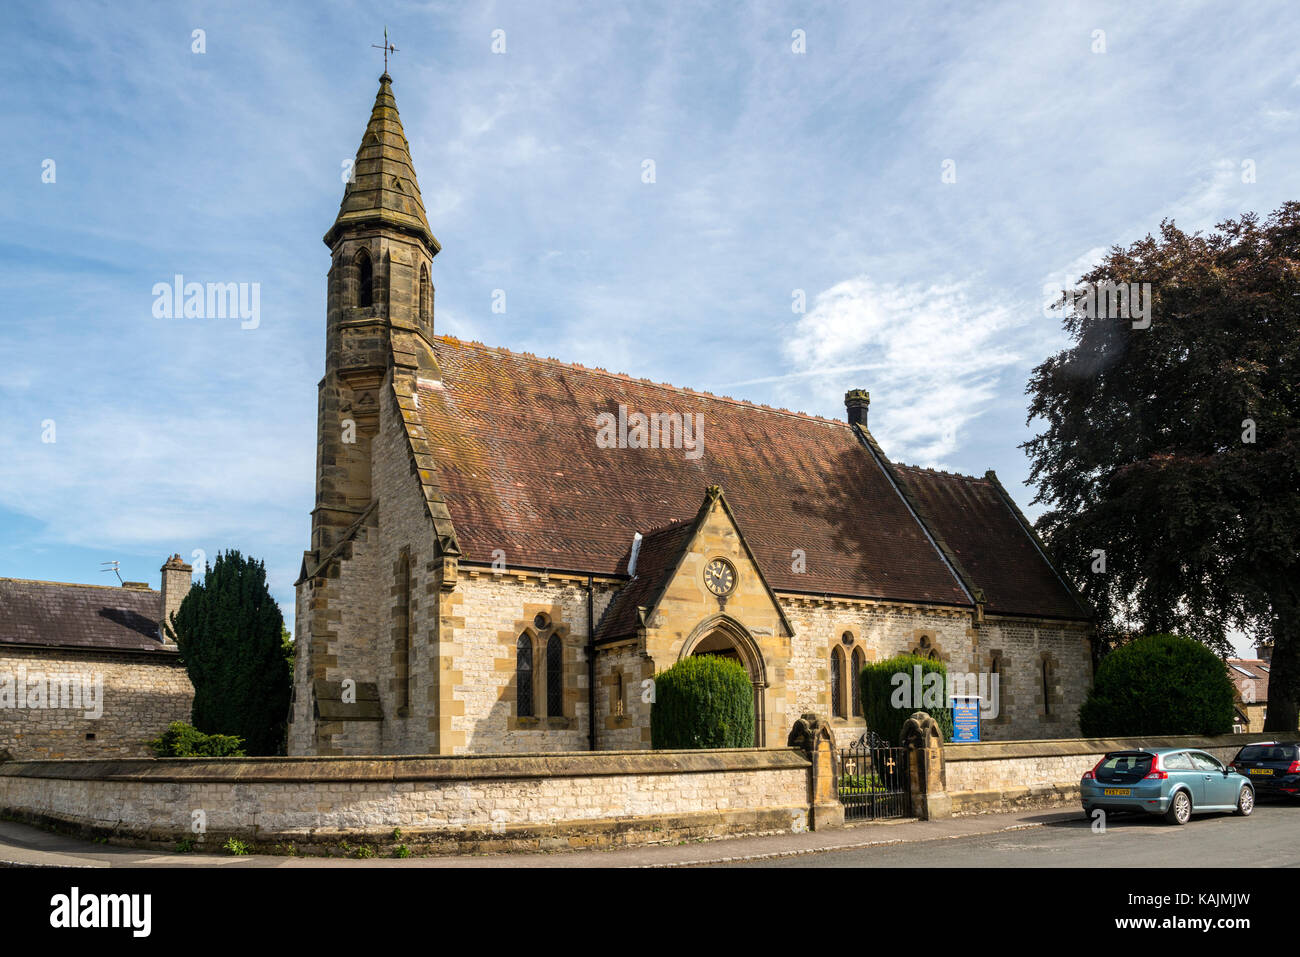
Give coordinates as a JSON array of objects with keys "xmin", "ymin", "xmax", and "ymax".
[{"xmin": 1079, "ymin": 748, "xmax": 1255, "ymax": 824}]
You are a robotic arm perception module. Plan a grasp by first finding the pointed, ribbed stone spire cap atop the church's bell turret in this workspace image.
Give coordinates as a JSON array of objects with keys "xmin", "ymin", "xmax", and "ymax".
[{"xmin": 325, "ymin": 73, "xmax": 442, "ymax": 256}]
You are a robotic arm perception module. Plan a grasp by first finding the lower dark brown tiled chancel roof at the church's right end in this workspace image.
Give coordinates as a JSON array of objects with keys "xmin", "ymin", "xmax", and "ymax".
[{"xmin": 894, "ymin": 465, "xmax": 1088, "ymax": 618}]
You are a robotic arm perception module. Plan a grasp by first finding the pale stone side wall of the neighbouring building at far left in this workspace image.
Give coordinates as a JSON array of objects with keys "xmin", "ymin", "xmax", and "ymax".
[{"xmin": 0, "ymin": 648, "xmax": 194, "ymax": 759}]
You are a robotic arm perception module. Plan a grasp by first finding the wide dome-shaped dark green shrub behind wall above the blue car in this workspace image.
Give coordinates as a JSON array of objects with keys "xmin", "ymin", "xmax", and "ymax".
[{"xmin": 1079, "ymin": 635, "xmax": 1232, "ymax": 737}]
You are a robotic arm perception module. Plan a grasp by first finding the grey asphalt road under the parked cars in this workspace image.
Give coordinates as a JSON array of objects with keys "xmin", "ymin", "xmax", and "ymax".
[{"xmin": 710, "ymin": 802, "xmax": 1300, "ymax": 867}]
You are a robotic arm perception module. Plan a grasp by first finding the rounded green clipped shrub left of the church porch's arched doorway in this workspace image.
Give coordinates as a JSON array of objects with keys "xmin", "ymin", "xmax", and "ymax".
[{"xmin": 650, "ymin": 655, "xmax": 754, "ymax": 749}]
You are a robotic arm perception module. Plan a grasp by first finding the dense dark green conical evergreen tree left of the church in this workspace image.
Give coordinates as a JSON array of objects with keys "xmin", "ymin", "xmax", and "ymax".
[{"xmin": 168, "ymin": 551, "xmax": 291, "ymax": 754}]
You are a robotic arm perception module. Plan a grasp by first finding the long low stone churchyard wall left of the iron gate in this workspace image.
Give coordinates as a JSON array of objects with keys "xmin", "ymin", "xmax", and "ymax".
[{"xmin": 0, "ymin": 749, "xmax": 809, "ymax": 849}]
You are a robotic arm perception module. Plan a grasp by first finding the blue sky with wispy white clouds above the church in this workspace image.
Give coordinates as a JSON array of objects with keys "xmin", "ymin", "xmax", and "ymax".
[{"xmin": 0, "ymin": 0, "xmax": 1300, "ymax": 650}]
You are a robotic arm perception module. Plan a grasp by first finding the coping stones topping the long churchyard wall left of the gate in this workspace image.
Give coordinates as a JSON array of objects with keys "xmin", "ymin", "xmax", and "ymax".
[{"xmin": 0, "ymin": 748, "xmax": 810, "ymax": 784}]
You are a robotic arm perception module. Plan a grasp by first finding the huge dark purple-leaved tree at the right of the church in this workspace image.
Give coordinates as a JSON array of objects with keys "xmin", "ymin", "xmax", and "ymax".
[{"xmin": 1024, "ymin": 203, "xmax": 1300, "ymax": 732}]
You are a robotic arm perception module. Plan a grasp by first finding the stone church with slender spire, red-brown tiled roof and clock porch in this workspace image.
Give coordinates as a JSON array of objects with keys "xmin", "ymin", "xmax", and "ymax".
[{"xmin": 289, "ymin": 72, "xmax": 1095, "ymax": 755}]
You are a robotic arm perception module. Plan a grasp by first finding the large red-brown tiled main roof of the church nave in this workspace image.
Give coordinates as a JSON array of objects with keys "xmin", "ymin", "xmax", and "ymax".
[{"xmin": 405, "ymin": 335, "xmax": 1086, "ymax": 618}]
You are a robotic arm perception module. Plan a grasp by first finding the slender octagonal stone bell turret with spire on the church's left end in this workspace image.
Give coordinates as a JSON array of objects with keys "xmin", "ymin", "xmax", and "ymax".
[{"xmin": 312, "ymin": 73, "xmax": 442, "ymax": 560}]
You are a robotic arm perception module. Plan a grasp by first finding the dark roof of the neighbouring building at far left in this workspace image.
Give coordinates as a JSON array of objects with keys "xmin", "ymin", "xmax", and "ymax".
[{"xmin": 0, "ymin": 579, "xmax": 176, "ymax": 654}]
